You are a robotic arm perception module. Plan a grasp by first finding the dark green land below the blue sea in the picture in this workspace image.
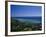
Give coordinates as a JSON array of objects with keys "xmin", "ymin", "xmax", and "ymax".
[{"xmin": 11, "ymin": 19, "xmax": 42, "ymax": 32}]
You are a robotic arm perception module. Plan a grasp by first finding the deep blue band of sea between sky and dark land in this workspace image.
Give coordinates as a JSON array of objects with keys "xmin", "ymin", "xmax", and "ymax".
[{"xmin": 12, "ymin": 17, "xmax": 42, "ymax": 23}]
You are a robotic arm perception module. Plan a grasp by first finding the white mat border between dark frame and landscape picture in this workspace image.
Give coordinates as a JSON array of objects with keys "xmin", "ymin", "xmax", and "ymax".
[{"xmin": 8, "ymin": 2, "xmax": 44, "ymax": 35}]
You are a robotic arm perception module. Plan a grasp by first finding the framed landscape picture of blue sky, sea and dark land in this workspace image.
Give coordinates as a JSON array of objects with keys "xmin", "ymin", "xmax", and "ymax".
[{"xmin": 10, "ymin": 5, "xmax": 42, "ymax": 32}]
